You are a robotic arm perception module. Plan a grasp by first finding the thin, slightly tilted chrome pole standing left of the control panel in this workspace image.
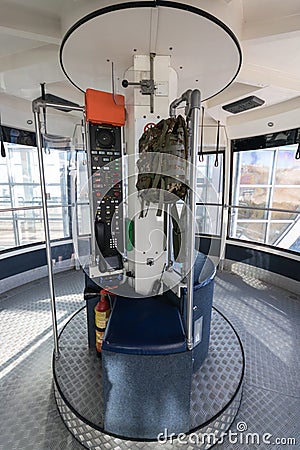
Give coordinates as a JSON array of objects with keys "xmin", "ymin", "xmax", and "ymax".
[{"xmin": 33, "ymin": 105, "xmax": 59, "ymax": 358}]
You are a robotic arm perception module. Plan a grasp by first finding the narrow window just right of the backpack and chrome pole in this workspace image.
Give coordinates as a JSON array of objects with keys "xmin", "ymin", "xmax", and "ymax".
[{"xmin": 196, "ymin": 153, "xmax": 224, "ymax": 236}]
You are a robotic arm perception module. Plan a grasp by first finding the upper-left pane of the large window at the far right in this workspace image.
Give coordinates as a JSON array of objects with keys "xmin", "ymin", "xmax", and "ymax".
[{"xmin": 234, "ymin": 150, "xmax": 274, "ymax": 185}]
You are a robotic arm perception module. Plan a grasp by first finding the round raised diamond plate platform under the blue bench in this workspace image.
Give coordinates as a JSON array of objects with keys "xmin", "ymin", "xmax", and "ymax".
[{"xmin": 54, "ymin": 308, "xmax": 244, "ymax": 450}]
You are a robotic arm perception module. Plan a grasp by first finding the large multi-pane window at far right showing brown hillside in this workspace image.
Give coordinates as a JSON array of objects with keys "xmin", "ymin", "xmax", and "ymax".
[{"xmin": 229, "ymin": 144, "xmax": 300, "ymax": 252}]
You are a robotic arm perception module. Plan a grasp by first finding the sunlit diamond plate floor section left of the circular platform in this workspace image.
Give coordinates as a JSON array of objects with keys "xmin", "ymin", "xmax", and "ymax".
[{"xmin": 0, "ymin": 271, "xmax": 84, "ymax": 450}]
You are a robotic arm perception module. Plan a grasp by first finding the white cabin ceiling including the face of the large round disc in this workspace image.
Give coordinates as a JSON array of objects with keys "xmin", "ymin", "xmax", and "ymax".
[{"xmin": 0, "ymin": 0, "xmax": 300, "ymax": 129}]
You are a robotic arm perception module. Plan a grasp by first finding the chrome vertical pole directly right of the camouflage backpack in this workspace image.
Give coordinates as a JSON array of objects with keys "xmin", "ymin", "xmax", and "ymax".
[{"xmin": 187, "ymin": 89, "xmax": 201, "ymax": 350}]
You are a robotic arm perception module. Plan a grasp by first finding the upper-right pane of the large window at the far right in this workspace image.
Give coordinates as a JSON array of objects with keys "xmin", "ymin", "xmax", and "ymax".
[{"xmin": 275, "ymin": 145, "xmax": 300, "ymax": 185}]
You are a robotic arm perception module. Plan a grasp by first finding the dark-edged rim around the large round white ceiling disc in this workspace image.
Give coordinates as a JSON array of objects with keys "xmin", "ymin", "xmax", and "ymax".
[{"xmin": 59, "ymin": 0, "xmax": 242, "ymax": 101}]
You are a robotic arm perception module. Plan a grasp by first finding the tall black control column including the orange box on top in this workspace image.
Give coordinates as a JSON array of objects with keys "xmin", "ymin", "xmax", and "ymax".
[{"xmin": 86, "ymin": 89, "xmax": 125, "ymax": 285}]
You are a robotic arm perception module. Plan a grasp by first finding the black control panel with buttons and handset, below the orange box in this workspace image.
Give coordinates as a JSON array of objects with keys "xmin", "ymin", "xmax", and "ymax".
[{"xmin": 89, "ymin": 123, "xmax": 123, "ymax": 272}]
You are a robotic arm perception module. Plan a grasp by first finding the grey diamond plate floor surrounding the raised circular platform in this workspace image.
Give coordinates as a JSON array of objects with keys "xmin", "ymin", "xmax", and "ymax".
[{"xmin": 0, "ymin": 271, "xmax": 300, "ymax": 450}]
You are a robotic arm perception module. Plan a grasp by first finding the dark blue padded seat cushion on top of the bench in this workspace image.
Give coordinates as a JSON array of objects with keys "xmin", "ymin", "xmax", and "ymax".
[{"xmin": 102, "ymin": 296, "xmax": 186, "ymax": 355}]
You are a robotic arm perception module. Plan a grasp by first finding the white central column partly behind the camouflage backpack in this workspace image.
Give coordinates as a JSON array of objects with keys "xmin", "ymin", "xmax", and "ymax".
[{"xmin": 126, "ymin": 55, "xmax": 177, "ymax": 295}]
